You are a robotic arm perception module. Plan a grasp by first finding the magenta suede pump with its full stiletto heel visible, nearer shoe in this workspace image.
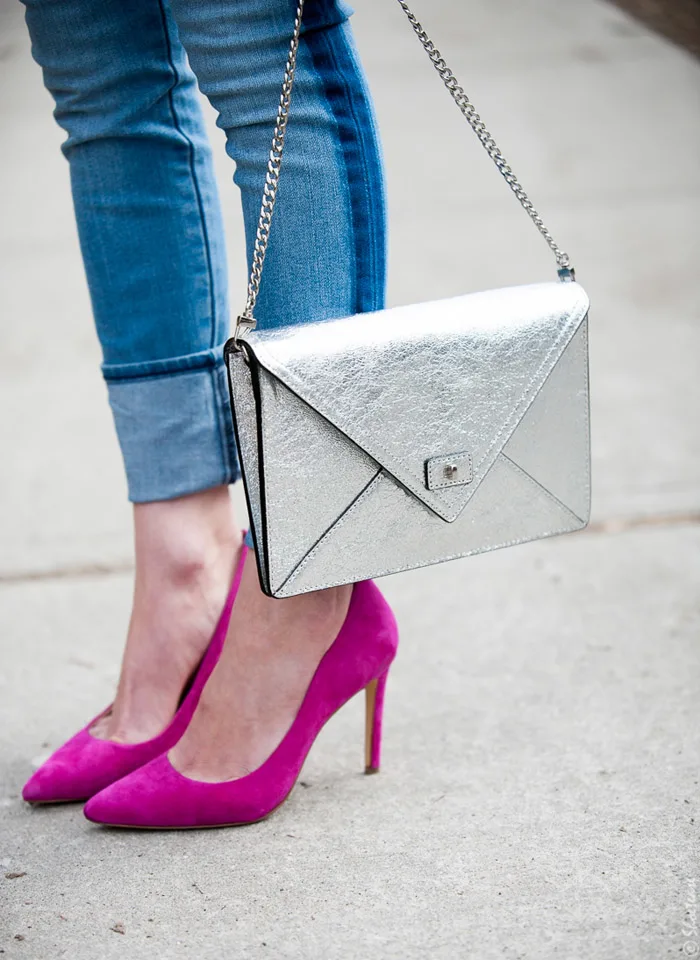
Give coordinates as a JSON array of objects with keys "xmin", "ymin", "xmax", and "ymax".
[{"xmin": 85, "ymin": 581, "xmax": 398, "ymax": 829}]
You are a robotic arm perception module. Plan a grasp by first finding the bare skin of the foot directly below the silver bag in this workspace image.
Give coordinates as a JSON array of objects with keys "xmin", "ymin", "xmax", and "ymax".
[{"xmin": 169, "ymin": 555, "xmax": 352, "ymax": 782}]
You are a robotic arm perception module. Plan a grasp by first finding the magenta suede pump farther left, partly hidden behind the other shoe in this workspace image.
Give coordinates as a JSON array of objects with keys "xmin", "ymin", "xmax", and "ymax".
[{"xmin": 22, "ymin": 544, "xmax": 248, "ymax": 803}]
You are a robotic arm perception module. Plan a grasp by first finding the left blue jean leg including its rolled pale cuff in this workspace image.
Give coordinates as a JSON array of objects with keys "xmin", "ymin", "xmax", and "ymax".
[{"xmin": 24, "ymin": 0, "xmax": 238, "ymax": 501}]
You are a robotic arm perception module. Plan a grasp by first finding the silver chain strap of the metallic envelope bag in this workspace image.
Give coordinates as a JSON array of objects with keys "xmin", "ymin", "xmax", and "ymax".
[{"xmin": 233, "ymin": 0, "xmax": 575, "ymax": 340}]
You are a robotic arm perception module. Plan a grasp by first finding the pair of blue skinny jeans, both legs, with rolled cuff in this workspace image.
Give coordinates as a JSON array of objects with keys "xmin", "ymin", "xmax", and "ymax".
[{"xmin": 23, "ymin": 0, "xmax": 386, "ymax": 502}]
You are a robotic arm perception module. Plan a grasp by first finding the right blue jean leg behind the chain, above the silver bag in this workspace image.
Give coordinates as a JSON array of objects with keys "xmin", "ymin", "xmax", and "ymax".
[{"xmin": 166, "ymin": 0, "xmax": 386, "ymax": 327}]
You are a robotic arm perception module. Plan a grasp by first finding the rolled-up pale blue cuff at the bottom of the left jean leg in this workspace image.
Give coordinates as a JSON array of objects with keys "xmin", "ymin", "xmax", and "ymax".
[{"xmin": 103, "ymin": 347, "xmax": 240, "ymax": 503}]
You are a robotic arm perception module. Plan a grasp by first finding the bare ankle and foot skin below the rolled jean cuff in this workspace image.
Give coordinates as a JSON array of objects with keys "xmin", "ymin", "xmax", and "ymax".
[{"xmin": 91, "ymin": 487, "xmax": 242, "ymax": 743}]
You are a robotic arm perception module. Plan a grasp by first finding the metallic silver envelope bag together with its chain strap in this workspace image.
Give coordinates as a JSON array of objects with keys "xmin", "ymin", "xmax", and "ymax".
[{"xmin": 226, "ymin": 0, "xmax": 590, "ymax": 597}]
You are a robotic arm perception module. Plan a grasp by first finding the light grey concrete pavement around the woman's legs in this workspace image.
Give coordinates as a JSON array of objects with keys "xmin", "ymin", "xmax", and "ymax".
[{"xmin": 0, "ymin": 0, "xmax": 700, "ymax": 960}]
